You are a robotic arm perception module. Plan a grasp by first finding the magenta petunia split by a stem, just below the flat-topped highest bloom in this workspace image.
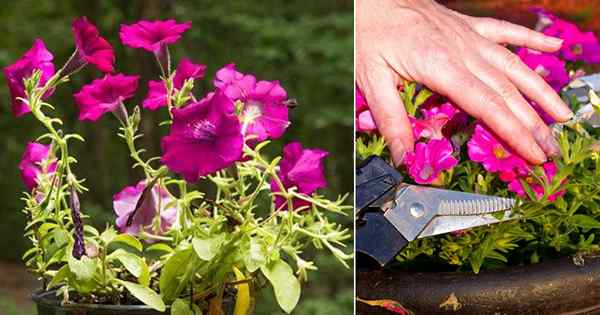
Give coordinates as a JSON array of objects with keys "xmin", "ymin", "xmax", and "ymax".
[{"xmin": 142, "ymin": 58, "xmax": 206, "ymax": 110}]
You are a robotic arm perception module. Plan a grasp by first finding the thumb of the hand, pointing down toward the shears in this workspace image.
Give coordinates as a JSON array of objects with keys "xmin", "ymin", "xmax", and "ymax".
[{"xmin": 357, "ymin": 66, "xmax": 414, "ymax": 165}]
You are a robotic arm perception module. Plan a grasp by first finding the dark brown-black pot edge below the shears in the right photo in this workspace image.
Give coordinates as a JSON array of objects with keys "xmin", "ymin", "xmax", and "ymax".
[{"xmin": 357, "ymin": 256, "xmax": 600, "ymax": 315}]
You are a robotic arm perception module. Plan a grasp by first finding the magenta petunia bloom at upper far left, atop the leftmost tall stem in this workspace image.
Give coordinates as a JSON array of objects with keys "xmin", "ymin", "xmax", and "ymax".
[{"xmin": 4, "ymin": 39, "xmax": 54, "ymax": 117}]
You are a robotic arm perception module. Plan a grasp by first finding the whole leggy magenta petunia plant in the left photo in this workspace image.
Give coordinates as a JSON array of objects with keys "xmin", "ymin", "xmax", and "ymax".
[{"xmin": 4, "ymin": 17, "xmax": 352, "ymax": 314}]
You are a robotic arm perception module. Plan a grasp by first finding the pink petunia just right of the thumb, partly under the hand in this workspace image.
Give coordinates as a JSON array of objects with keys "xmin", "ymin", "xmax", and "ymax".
[{"xmin": 410, "ymin": 102, "xmax": 459, "ymax": 140}]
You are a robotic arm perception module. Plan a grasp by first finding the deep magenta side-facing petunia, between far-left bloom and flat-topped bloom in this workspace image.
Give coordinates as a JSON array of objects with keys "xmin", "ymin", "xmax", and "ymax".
[{"xmin": 71, "ymin": 16, "xmax": 115, "ymax": 72}]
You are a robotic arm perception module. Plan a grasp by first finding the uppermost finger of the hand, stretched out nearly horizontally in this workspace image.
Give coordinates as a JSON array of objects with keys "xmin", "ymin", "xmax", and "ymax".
[{"xmin": 467, "ymin": 17, "xmax": 563, "ymax": 52}]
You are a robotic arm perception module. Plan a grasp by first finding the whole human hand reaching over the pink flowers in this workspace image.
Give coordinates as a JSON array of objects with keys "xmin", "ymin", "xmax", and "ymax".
[{"xmin": 355, "ymin": 0, "xmax": 573, "ymax": 165}]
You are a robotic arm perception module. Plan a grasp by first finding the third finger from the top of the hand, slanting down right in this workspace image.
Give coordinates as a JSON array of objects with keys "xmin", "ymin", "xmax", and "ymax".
[{"xmin": 467, "ymin": 56, "xmax": 560, "ymax": 156}]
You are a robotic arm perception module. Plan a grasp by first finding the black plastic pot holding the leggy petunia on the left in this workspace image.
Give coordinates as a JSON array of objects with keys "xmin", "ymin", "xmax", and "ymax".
[{"xmin": 31, "ymin": 290, "xmax": 235, "ymax": 315}]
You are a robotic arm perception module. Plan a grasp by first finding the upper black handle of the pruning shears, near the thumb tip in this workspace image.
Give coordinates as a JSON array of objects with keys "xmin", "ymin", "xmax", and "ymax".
[{"xmin": 355, "ymin": 155, "xmax": 402, "ymax": 215}]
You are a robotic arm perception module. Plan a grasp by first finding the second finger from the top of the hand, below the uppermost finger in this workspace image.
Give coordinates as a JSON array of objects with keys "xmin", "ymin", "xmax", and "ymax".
[{"xmin": 481, "ymin": 44, "xmax": 573, "ymax": 122}]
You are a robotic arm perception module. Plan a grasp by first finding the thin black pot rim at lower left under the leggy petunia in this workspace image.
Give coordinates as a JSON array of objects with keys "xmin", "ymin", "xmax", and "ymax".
[{"xmin": 31, "ymin": 289, "xmax": 171, "ymax": 312}]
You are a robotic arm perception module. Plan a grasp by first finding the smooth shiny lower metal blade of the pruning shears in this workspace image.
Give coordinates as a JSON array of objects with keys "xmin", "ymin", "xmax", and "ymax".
[{"xmin": 417, "ymin": 210, "xmax": 518, "ymax": 238}]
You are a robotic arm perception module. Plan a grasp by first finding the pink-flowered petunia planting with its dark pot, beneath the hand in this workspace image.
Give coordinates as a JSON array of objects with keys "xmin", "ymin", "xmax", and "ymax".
[{"xmin": 356, "ymin": 10, "xmax": 600, "ymax": 314}]
